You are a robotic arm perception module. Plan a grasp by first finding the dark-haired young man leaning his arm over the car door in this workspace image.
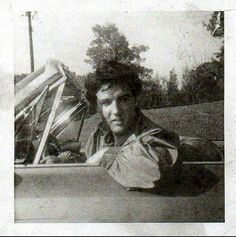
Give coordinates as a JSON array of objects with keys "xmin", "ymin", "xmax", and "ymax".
[{"xmin": 85, "ymin": 61, "xmax": 181, "ymax": 188}]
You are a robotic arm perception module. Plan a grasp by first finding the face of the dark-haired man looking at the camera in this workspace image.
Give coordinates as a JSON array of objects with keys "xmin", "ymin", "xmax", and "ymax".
[{"xmin": 96, "ymin": 84, "xmax": 136, "ymax": 136}]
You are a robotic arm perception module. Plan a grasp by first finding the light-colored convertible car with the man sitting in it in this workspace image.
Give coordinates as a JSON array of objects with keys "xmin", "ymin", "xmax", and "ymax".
[{"xmin": 14, "ymin": 60, "xmax": 224, "ymax": 223}]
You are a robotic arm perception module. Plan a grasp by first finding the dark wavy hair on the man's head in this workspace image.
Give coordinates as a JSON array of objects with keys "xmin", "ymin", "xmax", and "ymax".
[{"xmin": 85, "ymin": 60, "xmax": 142, "ymax": 109}]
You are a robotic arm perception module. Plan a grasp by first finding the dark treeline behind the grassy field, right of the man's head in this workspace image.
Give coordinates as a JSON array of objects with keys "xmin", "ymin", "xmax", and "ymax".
[{"xmin": 138, "ymin": 59, "xmax": 224, "ymax": 109}]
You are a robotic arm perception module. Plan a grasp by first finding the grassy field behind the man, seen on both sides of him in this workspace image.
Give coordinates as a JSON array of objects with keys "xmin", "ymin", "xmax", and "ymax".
[{"xmin": 60, "ymin": 101, "xmax": 224, "ymax": 146}]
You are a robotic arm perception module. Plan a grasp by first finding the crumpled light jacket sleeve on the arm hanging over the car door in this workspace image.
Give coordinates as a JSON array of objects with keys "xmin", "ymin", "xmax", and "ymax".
[{"xmin": 101, "ymin": 129, "xmax": 179, "ymax": 188}]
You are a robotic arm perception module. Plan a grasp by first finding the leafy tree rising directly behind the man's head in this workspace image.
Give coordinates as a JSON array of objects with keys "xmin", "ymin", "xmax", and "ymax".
[{"xmin": 85, "ymin": 24, "xmax": 153, "ymax": 79}]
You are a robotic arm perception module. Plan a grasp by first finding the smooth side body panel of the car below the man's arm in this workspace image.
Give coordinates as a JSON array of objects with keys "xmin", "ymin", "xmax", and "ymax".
[{"xmin": 15, "ymin": 164, "xmax": 224, "ymax": 223}]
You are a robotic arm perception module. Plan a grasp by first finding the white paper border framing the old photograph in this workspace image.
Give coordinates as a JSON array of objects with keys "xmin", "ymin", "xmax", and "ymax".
[{"xmin": 0, "ymin": 0, "xmax": 236, "ymax": 236}]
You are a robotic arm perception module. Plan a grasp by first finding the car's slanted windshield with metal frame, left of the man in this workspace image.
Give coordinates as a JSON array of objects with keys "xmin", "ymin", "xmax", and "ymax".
[{"xmin": 15, "ymin": 59, "xmax": 87, "ymax": 164}]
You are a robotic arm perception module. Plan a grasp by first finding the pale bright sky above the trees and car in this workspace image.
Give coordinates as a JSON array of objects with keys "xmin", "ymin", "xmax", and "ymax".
[{"xmin": 14, "ymin": 11, "xmax": 222, "ymax": 80}]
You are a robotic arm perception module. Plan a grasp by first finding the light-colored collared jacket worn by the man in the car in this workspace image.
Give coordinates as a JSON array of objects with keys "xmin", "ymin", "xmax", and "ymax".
[{"xmin": 85, "ymin": 111, "xmax": 181, "ymax": 188}]
